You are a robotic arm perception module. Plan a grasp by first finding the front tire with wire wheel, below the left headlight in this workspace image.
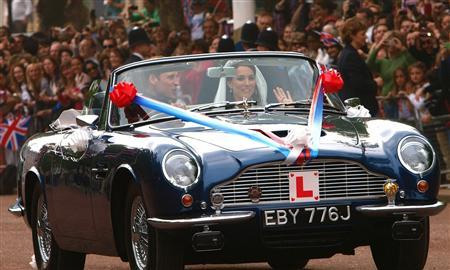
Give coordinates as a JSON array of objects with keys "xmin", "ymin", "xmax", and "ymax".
[{"xmin": 124, "ymin": 184, "xmax": 184, "ymax": 270}]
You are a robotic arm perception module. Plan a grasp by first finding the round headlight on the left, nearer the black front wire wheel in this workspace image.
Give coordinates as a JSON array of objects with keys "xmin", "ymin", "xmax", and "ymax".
[{"xmin": 163, "ymin": 149, "xmax": 200, "ymax": 188}]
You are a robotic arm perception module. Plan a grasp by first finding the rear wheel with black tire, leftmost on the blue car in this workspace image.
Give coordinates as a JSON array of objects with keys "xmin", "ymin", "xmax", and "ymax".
[{"xmin": 31, "ymin": 184, "xmax": 86, "ymax": 270}]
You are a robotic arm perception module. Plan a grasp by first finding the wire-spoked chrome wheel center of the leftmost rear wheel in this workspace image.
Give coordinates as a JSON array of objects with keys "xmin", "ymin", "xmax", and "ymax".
[{"xmin": 36, "ymin": 195, "xmax": 52, "ymax": 264}]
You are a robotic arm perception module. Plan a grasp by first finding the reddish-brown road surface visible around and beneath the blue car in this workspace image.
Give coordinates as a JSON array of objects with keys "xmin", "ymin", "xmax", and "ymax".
[{"xmin": 0, "ymin": 195, "xmax": 450, "ymax": 270}]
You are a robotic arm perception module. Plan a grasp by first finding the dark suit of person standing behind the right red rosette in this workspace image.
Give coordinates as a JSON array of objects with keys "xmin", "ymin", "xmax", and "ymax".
[{"xmin": 337, "ymin": 45, "xmax": 378, "ymax": 116}]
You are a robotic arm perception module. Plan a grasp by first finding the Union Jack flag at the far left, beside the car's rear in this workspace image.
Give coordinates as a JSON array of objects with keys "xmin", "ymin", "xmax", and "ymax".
[{"xmin": 0, "ymin": 115, "xmax": 30, "ymax": 151}]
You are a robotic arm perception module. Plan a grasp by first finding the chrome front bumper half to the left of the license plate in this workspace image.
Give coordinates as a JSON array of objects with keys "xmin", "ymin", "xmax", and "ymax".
[{"xmin": 147, "ymin": 211, "xmax": 255, "ymax": 229}]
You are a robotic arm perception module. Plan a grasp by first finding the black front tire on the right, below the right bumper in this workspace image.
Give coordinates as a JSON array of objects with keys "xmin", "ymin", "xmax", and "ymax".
[{"xmin": 370, "ymin": 217, "xmax": 430, "ymax": 270}]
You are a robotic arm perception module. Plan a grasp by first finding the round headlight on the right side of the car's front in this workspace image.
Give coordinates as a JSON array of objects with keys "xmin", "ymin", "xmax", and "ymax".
[{"xmin": 398, "ymin": 136, "xmax": 435, "ymax": 174}]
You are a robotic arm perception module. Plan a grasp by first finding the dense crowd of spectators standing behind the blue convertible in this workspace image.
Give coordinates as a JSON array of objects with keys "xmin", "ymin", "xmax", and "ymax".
[{"xmin": 0, "ymin": 0, "xmax": 450, "ymax": 168}]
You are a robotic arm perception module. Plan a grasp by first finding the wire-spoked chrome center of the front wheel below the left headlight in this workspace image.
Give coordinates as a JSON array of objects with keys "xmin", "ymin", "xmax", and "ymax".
[{"xmin": 130, "ymin": 196, "xmax": 149, "ymax": 270}]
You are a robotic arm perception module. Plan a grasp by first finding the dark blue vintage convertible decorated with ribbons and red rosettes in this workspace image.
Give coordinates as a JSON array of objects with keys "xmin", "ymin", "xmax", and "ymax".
[{"xmin": 9, "ymin": 52, "xmax": 445, "ymax": 270}]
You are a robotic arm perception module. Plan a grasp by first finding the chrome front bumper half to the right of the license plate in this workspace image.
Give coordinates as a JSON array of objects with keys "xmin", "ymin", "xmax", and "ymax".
[{"xmin": 356, "ymin": 201, "xmax": 446, "ymax": 216}]
